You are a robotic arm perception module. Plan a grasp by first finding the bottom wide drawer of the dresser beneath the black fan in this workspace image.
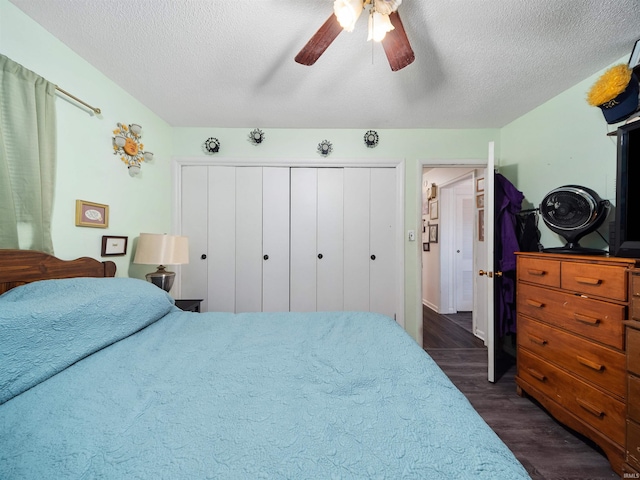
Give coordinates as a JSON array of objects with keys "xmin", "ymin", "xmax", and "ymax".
[{"xmin": 518, "ymin": 349, "xmax": 625, "ymax": 445}]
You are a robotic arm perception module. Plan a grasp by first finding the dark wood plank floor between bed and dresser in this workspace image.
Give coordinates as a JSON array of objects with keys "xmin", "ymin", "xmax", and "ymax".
[{"xmin": 423, "ymin": 307, "xmax": 619, "ymax": 480}]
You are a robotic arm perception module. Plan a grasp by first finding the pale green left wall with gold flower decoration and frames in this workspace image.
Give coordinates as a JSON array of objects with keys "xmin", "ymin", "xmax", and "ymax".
[{"xmin": 0, "ymin": 0, "xmax": 172, "ymax": 277}]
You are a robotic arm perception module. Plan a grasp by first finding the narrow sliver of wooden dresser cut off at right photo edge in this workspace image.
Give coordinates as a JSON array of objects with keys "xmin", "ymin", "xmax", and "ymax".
[{"xmin": 622, "ymin": 269, "xmax": 640, "ymax": 478}]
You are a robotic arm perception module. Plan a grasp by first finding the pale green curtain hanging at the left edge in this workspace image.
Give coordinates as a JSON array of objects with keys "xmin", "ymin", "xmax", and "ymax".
[{"xmin": 0, "ymin": 55, "xmax": 56, "ymax": 254}]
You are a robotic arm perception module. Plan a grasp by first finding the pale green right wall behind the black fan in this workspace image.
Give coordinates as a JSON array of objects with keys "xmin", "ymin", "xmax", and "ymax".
[{"xmin": 500, "ymin": 58, "xmax": 627, "ymax": 248}]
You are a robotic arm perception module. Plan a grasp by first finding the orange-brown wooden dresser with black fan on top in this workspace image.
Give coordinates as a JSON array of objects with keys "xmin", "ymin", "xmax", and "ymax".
[{"xmin": 516, "ymin": 253, "xmax": 638, "ymax": 475}]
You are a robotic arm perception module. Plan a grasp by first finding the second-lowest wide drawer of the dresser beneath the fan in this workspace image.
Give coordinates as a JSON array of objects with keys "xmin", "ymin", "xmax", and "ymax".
[{"xmin": 517, "ymin": 316, "xmax": 627, "ymax": 398}]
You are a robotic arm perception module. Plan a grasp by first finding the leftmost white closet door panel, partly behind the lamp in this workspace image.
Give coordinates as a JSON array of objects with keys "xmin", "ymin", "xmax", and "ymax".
[{"xmin": 180, "ymin": 166, "xmax": 208, "ymax": 312}]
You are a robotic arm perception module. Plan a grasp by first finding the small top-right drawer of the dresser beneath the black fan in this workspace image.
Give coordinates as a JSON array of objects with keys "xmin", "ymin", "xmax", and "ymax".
[{"xmin": 560, "ymin": 262, "xmax": 628, "ymax": 302}]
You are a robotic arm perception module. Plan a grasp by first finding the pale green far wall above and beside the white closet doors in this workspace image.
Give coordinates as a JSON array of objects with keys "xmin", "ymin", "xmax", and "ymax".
[{"xmin": 173, "ymin": 129, "xmax": 499, "ymax": 339}]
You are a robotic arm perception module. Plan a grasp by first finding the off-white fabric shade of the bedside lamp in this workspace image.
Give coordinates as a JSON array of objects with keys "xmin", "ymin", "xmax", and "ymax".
[{"xmin": 133, "ymin": 233, "xmax": 189, "ymax": 265}]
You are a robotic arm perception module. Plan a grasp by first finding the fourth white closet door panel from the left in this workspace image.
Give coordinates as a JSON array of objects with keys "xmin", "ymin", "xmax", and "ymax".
[{"xmin": 262, "ymin": 167, "xmax": 289, "ymax": 312}]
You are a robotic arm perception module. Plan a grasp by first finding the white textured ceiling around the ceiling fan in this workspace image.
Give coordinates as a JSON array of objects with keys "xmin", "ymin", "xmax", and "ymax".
[{"xmin": 10, "ymin": 0, "xmax": 640, "ymax": 128}]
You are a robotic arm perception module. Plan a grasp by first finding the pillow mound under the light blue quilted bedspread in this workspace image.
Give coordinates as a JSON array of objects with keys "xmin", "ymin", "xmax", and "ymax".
[{"xmin": 0, "ymin": 277, "xmax": 175, "ymax": 404}]
